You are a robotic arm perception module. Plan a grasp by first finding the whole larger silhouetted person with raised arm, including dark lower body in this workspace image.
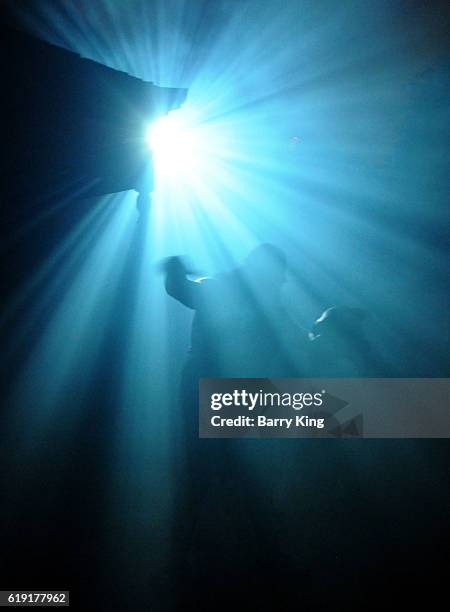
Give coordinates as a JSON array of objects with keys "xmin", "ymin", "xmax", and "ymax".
[{"xmin": 164, "ymin": 244, "xmax": 307, "ymax": 596}]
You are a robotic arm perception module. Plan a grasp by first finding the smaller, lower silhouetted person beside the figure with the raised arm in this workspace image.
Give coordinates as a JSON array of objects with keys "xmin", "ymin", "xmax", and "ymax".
[{"xmin": 309, "ymin": 306, "xmax": 380, "ymax": 378}]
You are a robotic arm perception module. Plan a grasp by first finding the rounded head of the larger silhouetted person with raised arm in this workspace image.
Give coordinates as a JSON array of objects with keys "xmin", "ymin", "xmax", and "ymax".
[{"xmin": 243, "ymin": 243, "xmax": 287, "ymax": 288}]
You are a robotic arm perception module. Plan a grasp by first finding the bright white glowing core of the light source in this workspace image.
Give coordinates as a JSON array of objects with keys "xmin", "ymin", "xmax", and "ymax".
[{"xmin": 145, "ymin": 115, "xmax": 200, "ymax": 174}]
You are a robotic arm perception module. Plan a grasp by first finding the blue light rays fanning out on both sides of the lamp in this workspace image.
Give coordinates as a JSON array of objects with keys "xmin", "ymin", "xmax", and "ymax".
[{"xmin": 4, "ymin": 0, "xmax": 450, "ymax": 604}]
